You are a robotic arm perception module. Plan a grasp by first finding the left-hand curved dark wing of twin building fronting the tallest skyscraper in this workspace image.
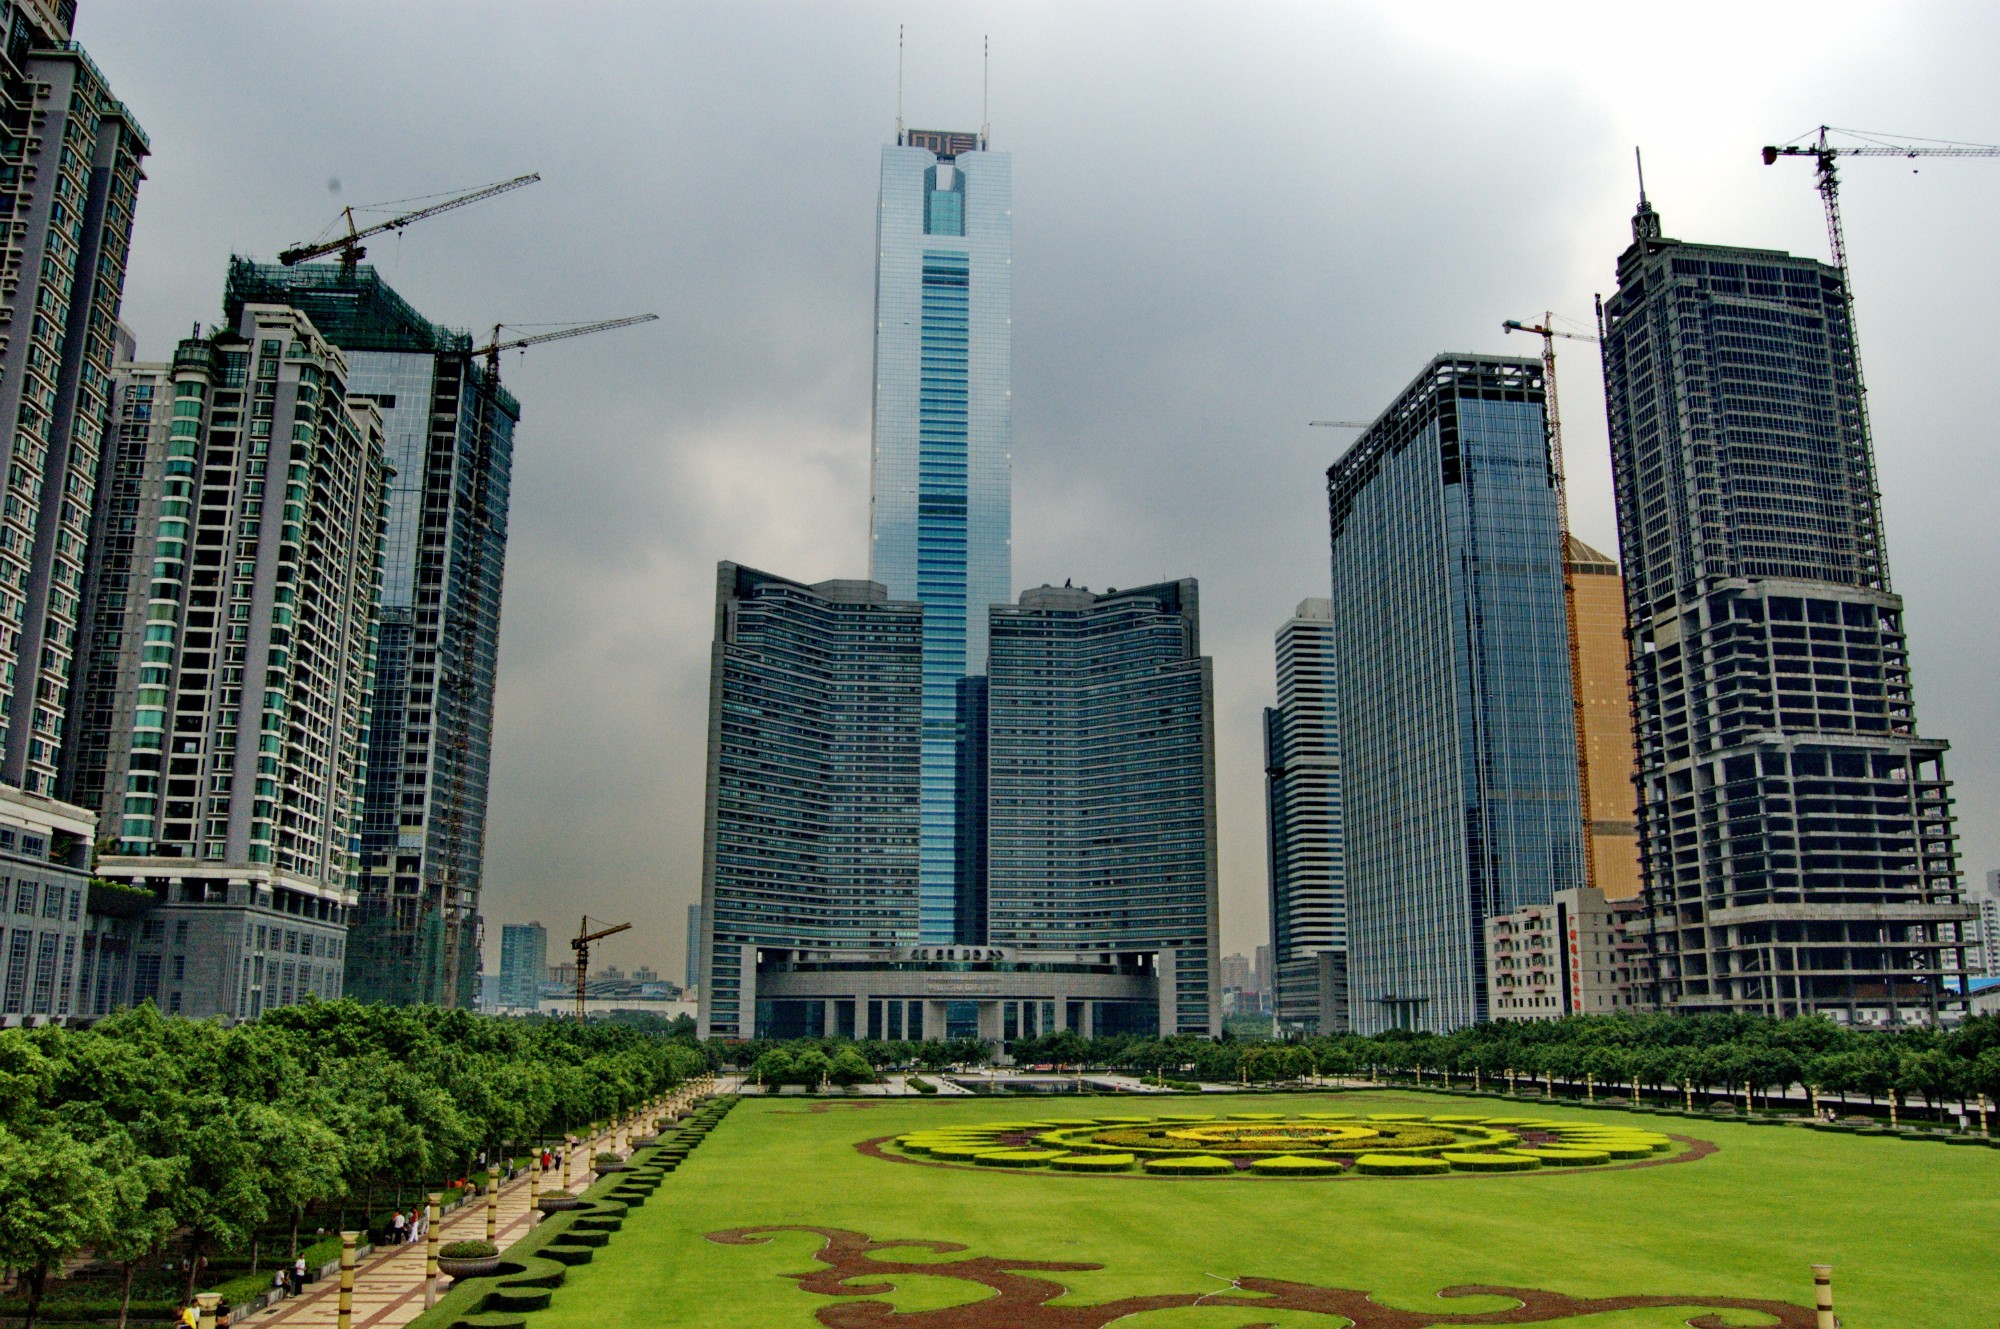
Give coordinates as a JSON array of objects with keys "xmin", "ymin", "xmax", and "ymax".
[{"xmin": 700, "ymin": 562, "xmax": 924, "ymax": 1039}]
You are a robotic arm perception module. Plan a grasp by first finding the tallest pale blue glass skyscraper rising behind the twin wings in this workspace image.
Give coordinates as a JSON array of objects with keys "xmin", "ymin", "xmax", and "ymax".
[{"xmin": 868, "ymin": 130, "xmax": 1014, "ymax": 943}]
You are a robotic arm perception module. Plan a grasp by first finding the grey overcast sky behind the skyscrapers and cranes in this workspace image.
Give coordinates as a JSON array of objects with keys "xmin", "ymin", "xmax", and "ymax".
[{"xmin": 78, "ymin": 0, "xmax": 2000, "ymax": 977}]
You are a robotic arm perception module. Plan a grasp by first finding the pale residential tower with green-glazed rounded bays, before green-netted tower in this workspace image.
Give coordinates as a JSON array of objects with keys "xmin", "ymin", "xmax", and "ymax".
[{"xmin": 64, "ymin": 304, "xmax": 386, "ymax": 1017}]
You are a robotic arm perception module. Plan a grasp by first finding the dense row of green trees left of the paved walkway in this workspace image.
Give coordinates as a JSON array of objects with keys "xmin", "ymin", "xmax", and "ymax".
[{"xmin": 0, "ymin": 1001, "xmax": 710, "ymax": 1329}]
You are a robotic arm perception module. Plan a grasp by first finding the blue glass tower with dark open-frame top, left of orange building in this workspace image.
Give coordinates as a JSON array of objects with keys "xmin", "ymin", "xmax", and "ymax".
[{"xmin": 1326, "ymin": 354, "xmax": 1584, "ymax": 1033}]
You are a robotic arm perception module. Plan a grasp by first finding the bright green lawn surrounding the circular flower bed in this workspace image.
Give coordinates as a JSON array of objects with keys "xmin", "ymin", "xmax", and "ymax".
[{"xmin": 530, "ymin": 1093, "xmax": 2000, "ymax": 1329}]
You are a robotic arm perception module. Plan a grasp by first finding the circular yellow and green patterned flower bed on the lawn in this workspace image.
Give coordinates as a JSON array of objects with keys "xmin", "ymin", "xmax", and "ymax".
[{"xmin": 870, "ymin": 1113, "xmax": 1694, "ymax": 1177}]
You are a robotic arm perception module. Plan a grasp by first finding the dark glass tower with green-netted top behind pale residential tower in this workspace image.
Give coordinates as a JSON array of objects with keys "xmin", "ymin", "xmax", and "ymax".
[{"xmin": 226, "ymin": 258, "xmax": 520, "ymax": 1007}]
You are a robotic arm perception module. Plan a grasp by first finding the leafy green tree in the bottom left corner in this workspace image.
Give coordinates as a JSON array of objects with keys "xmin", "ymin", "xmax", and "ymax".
[{"xmin": 0, "ymin": 1131, "xmax": 112, "ymax": 1329}]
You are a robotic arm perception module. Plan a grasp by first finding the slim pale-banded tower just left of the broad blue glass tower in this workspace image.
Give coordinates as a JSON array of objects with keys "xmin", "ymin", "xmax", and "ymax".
[{"xmin": 1264, "ymin": 600, "xmax": 1348, "ymax": 1033}]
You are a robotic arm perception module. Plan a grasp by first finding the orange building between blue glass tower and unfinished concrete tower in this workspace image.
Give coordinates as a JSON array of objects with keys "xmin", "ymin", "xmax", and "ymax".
[{"xmin": 1562, "ymin": 536, "xmax": 1644, "ymax": 901}]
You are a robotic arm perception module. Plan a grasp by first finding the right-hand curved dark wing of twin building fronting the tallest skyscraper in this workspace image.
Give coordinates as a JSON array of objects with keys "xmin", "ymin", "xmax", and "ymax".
[{"xmin": 986, "ymin": 580, "xmax": 1222, "ymax": 1035}]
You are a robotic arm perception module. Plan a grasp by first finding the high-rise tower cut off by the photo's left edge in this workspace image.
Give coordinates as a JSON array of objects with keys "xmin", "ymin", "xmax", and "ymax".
[{"xmin": 0, "ymin": 0, "xmax": 148, "ymax": 1017}]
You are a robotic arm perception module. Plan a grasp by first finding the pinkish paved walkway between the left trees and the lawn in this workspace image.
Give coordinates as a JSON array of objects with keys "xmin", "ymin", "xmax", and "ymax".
[{"xmin": 238, "ymin": 1087, "xmax": 720, "ymax": 1329}]
